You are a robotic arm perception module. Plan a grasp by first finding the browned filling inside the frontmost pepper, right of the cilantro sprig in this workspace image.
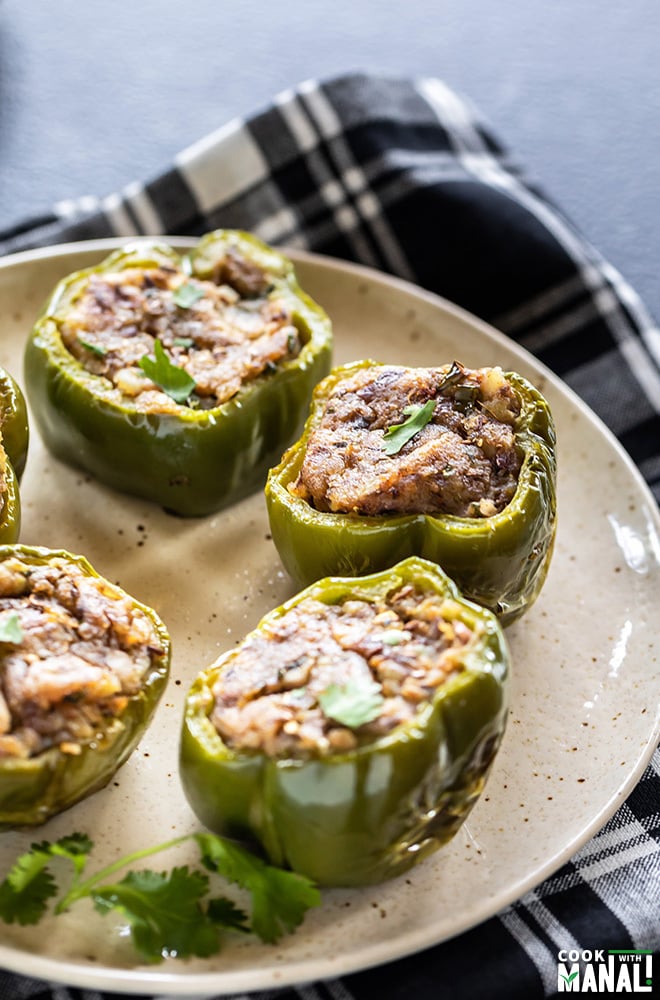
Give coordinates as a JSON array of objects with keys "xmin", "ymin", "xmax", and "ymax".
[{"xmin": 211, "ymin": 585, "xmax": 472, "ymax": 757}]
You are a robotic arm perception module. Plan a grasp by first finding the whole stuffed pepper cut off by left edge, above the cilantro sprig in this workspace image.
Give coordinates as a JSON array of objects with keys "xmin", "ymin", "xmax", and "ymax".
[{"xmin": 0, "ymin": 545, "xmax": 170, "ymax": 828}]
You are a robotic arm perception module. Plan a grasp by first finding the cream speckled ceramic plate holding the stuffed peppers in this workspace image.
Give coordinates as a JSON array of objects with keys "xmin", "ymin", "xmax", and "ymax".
[{"xmin": 0, "ymin": 241, "xmax": 660, "ymax": 996}]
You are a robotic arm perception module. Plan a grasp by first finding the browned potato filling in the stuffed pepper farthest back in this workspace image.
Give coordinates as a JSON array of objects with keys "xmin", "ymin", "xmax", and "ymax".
[{"xmin": 60, "ymin": 252, "xmax": 302, "ymax": 412}]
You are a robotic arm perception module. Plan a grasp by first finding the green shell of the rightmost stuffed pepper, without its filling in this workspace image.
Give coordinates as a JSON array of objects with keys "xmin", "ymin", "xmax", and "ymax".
[{"xmin": 266, "ymin": 361, "xmax": 556, "ymax": 624}]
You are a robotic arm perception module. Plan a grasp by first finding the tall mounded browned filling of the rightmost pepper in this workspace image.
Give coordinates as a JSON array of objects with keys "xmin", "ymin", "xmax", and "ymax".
[{"xmin": 289, "ymin": 362, "xmax": 521, "ymax": 517}]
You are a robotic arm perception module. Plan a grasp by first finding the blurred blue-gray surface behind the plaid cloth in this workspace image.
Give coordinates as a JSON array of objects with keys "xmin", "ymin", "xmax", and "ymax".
[{"xmin": 0, "ymin": 0, "xmax": 660, "ymax": 317}]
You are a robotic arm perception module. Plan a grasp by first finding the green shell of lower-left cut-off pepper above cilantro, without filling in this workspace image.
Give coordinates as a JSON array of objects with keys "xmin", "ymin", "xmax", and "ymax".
[{"xmin": 0, "ymin": 545, "xmax": 171, "ymax": 829}]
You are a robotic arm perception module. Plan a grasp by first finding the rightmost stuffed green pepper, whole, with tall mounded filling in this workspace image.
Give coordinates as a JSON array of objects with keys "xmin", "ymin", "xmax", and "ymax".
[{"xmin": 266, "ymin": 361, "xmax": 556, "ymax": 624}]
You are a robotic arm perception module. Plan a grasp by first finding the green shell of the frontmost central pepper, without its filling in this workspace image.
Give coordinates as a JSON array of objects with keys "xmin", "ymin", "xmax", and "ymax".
[{"xmin": 180, "ymin": 557, "xmax": 509, "ymax": 886}]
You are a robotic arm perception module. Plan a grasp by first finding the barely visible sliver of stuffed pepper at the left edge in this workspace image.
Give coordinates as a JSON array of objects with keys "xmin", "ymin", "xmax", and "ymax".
[{"xmin": 0, "ymin": 368, "xmax": 29, "ymax": 544}]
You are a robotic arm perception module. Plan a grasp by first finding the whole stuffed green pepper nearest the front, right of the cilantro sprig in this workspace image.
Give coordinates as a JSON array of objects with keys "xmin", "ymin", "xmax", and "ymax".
[{"xmin": 180, "ymin": 557, "xmax": 509, "ymax": 886}]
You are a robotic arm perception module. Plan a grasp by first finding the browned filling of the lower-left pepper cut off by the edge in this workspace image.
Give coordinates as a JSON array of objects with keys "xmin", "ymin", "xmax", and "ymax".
[{"xmin": 0, "ymin": 557, "xmax": 163, "ymax": 759}]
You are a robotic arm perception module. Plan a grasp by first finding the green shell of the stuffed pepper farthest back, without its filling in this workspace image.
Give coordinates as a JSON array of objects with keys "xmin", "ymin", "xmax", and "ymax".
[{"xmin": 25, "ymin": 230, "xmax": 332, "ymax": 516}]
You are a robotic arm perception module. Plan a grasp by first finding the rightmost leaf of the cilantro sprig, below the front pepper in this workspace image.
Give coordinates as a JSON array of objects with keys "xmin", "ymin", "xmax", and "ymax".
[{"xmin": 195, "ymin": 833, "xmax": 321, "ymax": 944}]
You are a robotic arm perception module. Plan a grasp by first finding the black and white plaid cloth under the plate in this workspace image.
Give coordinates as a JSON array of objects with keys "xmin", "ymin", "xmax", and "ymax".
[{"xmin": 0, "ymin": 75, "xmax": 660, "ymax": 1000}]
